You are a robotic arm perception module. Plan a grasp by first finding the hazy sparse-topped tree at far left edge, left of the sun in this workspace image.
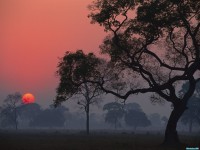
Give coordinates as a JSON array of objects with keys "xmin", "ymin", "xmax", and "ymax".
[{"xmin": 1, "ymin": 92, "xmax": 22, "ymax": 130}]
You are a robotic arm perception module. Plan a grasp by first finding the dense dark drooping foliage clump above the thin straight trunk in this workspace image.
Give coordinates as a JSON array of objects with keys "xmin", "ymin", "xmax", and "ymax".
[{"xmin": 54, "ymin": 50, "xmax": 100, "ymax": 105}]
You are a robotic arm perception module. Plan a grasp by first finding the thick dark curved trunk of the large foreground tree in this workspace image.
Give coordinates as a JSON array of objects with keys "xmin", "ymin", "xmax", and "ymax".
[{"xmin": 163, "ymin": 105, "xmax": 186, "ymax": 146}]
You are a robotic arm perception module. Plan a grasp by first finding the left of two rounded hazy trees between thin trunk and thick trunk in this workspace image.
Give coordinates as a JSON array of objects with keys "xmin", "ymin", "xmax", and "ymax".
[{"xmin": 103, "ymin": 102, "xmax": 124, "ymax": 129}]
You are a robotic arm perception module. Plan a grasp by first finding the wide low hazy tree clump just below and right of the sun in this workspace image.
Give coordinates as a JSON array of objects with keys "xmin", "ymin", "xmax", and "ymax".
[{"xmin": 30, "ymin": 106, "xmax": 68, "ymax": 128}]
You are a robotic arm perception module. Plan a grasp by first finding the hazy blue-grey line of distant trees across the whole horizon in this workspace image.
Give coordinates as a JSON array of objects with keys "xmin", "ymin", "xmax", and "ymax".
[{"xmin": 0, "ymin": 92, "xmax": 200, "ymax": 133}]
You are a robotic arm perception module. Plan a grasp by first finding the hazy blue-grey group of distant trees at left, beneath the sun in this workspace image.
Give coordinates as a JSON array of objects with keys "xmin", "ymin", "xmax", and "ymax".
[{"xmin": 0, "ymin": 93, "xmax": 68, "ymax": 130}]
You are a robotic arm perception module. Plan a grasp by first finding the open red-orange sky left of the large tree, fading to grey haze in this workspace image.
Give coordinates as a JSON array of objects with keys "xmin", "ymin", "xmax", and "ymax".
[{"xmin": 0, "ymin": 0, "xmax": 171, "ymax": 116}]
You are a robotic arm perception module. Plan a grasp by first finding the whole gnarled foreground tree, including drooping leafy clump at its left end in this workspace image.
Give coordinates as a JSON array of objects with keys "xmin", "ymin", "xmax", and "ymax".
[{"xmin": 55, "ymin": 0, "xmax": 200, "ymax": 145}]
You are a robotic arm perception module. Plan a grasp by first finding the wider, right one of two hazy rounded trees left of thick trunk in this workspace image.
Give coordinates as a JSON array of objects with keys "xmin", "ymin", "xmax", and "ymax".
[{"xmin": 124, "ymin": 109, "xmax": 151, "ymax": 130}]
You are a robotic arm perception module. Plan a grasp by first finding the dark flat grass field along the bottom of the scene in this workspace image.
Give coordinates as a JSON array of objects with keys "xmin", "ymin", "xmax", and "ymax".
[{"xmin": 0, "ymin": 130, "xmax": 200, "ymax": 150}]
